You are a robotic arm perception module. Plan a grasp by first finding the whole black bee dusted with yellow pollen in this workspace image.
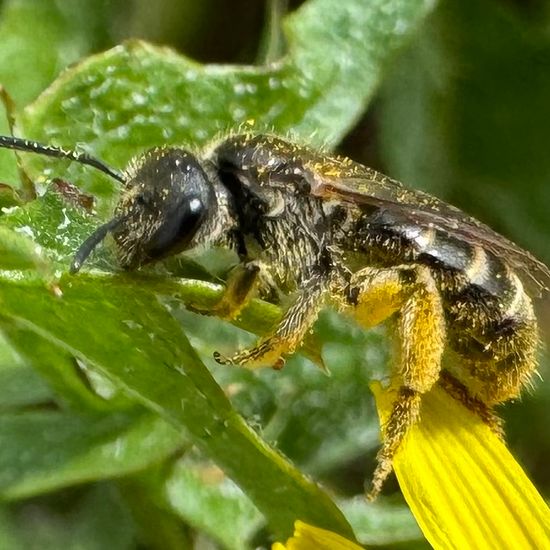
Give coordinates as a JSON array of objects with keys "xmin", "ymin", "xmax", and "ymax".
[{"xmin": 0, "ymin": 134, "xmax": 550, "ymax": 498}]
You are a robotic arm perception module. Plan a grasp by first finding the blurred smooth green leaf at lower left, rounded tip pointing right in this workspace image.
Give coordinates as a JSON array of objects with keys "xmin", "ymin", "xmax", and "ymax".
[{"xmin": 0, "ymin": 411, "xmax": 183, "ymax": 499}]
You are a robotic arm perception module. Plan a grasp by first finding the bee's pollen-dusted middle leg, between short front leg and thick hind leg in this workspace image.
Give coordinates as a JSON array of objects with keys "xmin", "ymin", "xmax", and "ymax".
[{"xmin": 214, "ymin": 275, "xmax": 330, "ymax": 368}]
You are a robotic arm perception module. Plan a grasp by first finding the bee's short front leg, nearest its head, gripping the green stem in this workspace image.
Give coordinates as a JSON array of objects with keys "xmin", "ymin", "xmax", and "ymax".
[{"xmin": 190, "ymin": 262, "xmax": 260, "ymax": 321}]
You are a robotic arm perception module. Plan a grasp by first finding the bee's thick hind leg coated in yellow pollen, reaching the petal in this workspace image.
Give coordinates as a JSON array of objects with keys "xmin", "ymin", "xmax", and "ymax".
[{"xmin": 349, "ymin": 265, "xmax": 445, "ymax": 499}]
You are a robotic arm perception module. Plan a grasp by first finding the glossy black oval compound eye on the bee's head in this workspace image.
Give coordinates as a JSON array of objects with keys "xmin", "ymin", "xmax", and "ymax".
[{"xmin": 146, "ymin": 197, "xmax": 207, "ymax": 260}]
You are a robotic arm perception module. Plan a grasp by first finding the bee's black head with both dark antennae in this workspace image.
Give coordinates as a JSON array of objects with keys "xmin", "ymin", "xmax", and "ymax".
[{"xmin": 0, "ymin": 136, "xmax": 236, "ymax": 273}]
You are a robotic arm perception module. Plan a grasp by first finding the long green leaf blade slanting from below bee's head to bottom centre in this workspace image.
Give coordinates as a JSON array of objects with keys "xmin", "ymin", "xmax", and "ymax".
[{"xmin": 0, "ymin": 277, "xmax": 352, "ymax": 537}]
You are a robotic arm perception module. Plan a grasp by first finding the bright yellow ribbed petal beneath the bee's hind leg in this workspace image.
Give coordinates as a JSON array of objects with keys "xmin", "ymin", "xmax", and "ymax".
[{"xmin": 373, "ymin": 385, "xmax": 550, "ymax": 550}]
